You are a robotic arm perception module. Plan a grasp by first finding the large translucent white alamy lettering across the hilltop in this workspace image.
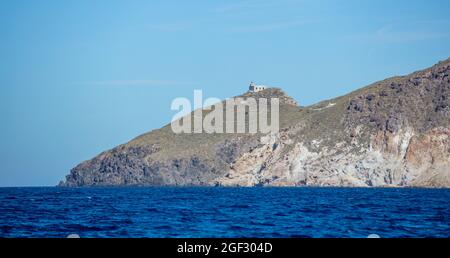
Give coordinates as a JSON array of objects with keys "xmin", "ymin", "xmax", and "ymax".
[{"xmin": 171, "ymin": 90, "xmax": 280, "ymax": 134}]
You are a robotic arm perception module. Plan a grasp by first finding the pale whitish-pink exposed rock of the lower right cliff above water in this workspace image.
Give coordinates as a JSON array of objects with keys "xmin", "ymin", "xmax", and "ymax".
[{"xmin": 218, "ymin": 128, "xmax": 450, "ymax": 187}]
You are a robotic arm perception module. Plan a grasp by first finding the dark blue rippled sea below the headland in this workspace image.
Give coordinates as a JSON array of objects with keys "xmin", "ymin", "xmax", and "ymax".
[{"xmin": 0, "ymin": 187, "xmax": 450, "ymax": 237}]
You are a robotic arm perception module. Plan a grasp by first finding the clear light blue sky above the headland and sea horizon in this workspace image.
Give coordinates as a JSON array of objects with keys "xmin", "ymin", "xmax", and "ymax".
[{"xmin": 0, "ymin": 0, "xmax": 450, "ymax": 186}]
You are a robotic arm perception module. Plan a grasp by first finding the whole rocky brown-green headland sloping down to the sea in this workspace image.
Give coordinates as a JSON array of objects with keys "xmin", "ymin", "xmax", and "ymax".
[{"xmin": 60, "ymin": 59, "xmax": 450, "ymax": 187}]
